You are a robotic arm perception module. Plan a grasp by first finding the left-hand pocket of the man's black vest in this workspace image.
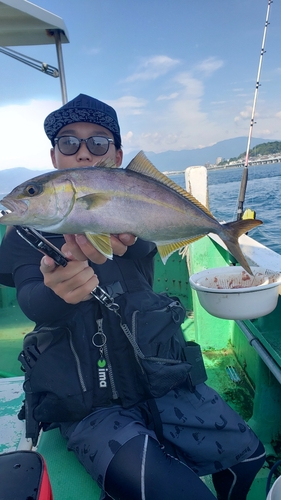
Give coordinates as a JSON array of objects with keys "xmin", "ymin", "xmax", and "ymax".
[{"xmin": 19, "ymin": 326, "xmax": 98, "ymax": 428}]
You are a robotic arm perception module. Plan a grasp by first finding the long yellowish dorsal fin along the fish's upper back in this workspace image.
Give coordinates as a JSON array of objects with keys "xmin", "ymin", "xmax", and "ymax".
[{"xmin": 126, "ymin": 151, "xmax": 215, "ymax": 219}]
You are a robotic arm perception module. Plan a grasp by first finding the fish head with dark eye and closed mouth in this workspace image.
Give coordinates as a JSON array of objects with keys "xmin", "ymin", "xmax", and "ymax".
[{"xmin": 0, "ymin": 171, "xmax": 76, "ymax": 230}]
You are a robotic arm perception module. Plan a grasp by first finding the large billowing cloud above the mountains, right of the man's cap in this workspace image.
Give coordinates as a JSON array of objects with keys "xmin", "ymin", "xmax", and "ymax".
[{"xmin": 122, "ymin": 71, "xmax": 220, "ymax": 153}]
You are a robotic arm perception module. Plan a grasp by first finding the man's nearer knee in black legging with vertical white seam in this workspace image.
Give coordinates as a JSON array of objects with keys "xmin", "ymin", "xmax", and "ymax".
[{"xmin": 105, "ymin": 434, "xmax": 215, "ymax": 500}]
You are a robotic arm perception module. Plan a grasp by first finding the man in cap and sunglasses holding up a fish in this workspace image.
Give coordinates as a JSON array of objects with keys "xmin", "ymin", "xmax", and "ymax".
[{"xmin": 0, "ymin": 95, "xmax": 265, "ymax": 500}]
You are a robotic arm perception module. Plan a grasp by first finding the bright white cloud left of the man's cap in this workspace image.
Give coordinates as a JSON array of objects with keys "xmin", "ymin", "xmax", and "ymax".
[{"xmin": 0, "ymin": 100, "xmax": 61, "ymax": 170}]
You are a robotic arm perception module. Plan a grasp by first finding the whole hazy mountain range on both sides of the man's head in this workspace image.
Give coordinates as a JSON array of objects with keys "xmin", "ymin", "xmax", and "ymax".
[{"xmin": 0, "ymin": 137, "xmax": 272, "ymax": 193}]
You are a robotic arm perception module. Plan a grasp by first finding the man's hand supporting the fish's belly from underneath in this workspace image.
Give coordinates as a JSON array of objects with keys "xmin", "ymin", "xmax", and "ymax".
[{"xmin": 61, "ymin": 233, "xmax": 136, "ymax": 264}]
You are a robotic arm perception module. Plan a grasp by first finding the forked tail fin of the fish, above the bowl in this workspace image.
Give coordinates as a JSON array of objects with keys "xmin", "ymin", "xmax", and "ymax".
[{"xmin": 219, "ymin": 219, "xmax": 262, "ymax": 275}]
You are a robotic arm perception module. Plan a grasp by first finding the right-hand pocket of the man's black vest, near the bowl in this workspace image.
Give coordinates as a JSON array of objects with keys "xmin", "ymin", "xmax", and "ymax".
[{"xmin": 116, "ymin": 293, "xmax": 191, "ymax": 398}]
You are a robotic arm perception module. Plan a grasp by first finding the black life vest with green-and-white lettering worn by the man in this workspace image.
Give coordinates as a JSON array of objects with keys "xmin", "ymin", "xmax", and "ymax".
[{"xmin": 19, "ymin": 248, "xmax": 191, "ymax": 441}]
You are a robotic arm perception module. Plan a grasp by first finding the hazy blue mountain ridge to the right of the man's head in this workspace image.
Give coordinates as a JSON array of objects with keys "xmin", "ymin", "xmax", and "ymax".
[{"xmin": 123, "ymin": 137, "xmax": 272, "ymax": 172}]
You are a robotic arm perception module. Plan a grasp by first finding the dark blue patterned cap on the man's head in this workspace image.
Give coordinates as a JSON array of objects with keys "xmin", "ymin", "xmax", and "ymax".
[{"xmin": 44, "ymin": 94, "xmax": 121, "ymax": 149}]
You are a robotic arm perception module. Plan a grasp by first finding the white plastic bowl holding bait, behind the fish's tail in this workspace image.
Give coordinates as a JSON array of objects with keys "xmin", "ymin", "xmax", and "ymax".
[{"xmin": 189, "ymin": 266, "xmax": 281, "ymax": 319}]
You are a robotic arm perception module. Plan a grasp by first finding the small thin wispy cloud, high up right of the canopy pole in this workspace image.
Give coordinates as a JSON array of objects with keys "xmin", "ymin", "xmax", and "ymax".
[{"xmin": 125, "ymin": 55, "xmax": 180, "ymax": 82}]
